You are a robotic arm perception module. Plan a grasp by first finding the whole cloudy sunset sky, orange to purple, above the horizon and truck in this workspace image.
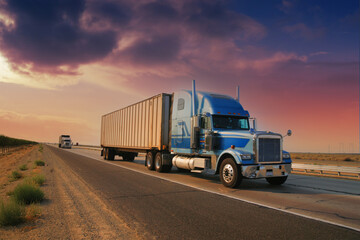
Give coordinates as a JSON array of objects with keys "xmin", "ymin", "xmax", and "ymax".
[{"xmin": 0, "ymin": 0, "xmax": 360, "ymax": 152}]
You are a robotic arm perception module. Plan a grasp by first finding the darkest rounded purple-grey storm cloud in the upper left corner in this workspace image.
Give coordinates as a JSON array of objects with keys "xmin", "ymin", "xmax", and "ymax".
[{"xmin": 1, "ymin": 0, "xmax": 116, "ymax": 69}]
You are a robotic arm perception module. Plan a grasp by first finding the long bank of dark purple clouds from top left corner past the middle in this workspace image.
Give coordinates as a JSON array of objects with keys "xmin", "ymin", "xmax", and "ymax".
[{"xmin": 0, "ymin": 0, "xmax": 262, "ymax": 73}]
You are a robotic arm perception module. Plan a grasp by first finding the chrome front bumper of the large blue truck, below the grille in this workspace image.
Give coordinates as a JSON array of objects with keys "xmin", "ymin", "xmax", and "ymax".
[{"xmin": 241, "ymin": 163, "xmax": 291, "ymax": 178}]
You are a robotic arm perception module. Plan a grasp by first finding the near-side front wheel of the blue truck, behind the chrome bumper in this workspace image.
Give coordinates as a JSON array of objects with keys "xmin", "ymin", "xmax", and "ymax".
[{"xmin": 219, "ymin": 158, "xmax": 242, "ymax": 188}]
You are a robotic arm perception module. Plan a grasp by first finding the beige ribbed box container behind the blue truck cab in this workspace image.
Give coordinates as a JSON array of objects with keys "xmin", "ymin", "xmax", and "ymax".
[{"xmin": 101, "ymin": 93, "xmax": 171, "ymax": 150}]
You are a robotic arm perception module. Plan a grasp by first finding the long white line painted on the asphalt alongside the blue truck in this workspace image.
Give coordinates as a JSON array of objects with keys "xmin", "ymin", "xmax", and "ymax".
[{"xmin": 63, "ymin": 149, "xmax": 360, "ymax": 232}]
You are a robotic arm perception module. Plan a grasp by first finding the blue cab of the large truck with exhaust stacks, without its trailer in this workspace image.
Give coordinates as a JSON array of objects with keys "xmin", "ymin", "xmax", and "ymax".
[{"xmin": 169, "ymin": 85, "xmax": 291, "ymax": 188}]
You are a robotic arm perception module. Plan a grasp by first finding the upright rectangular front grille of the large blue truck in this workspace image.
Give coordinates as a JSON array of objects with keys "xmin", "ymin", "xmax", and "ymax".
[{"xmin": 258, "ymin": 138, "xmax": 281, "ymax": 162}]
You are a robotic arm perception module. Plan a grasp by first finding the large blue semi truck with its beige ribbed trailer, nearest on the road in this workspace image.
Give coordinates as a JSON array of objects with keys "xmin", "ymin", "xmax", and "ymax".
[{"xmin": 100, "ymin": 82, "xmax": 291, "ymax": 188}]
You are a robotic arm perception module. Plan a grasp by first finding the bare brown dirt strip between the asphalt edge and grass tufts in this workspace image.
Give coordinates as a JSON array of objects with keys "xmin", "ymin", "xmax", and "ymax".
[{"xmin": 0, "ymin": 146, "xmax": 140, "ymax": 239}]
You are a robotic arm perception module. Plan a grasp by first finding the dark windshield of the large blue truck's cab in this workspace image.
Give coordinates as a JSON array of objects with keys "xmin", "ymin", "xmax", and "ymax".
[{"xmin": 213, "ymin": 115, "xmax": 249, "ymax": 130}]
